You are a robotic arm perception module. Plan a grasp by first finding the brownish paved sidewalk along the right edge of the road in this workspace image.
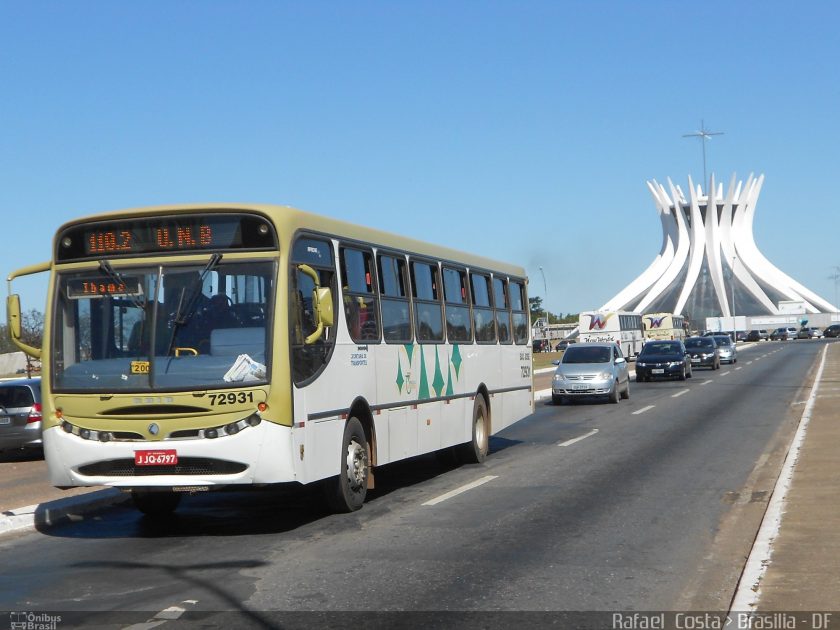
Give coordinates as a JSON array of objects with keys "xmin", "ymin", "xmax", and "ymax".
[{"xmin": 742, "ymin": 343, "xmax": 840, "ymax": 612}]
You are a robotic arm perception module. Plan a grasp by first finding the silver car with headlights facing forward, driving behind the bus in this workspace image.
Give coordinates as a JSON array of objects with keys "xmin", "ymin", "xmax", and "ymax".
[{"xmin": 551, "ymin": 343, "xmax": 630, "ymax": 405}]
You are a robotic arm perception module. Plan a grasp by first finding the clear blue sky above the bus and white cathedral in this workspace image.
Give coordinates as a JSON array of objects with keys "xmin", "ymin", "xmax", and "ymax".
[{"xmin": 0, "ymin": 0, "xmax": 840, "ymax": 320}]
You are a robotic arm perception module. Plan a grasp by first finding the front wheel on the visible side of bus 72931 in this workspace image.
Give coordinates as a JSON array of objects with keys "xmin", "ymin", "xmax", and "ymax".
[{"xmin": 324, "ymin": 418, "xmax": 370, "ymax": 512}]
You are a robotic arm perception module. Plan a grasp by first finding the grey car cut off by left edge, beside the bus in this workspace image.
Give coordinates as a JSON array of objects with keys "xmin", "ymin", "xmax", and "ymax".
[{"xmin": 0, "ymin": 378, "xmax": 41, "ymax": 451}]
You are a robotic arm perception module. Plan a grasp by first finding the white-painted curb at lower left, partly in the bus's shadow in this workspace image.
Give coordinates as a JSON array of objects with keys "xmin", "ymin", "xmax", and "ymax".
[{"xmin": 0, "ymin": 488, "xmax": 131, "ymax": 536}]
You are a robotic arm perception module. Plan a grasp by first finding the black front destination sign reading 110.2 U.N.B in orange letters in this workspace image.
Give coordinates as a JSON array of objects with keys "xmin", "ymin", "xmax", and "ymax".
[{"xmin": 56, "ymin": 214, "xmax": 276, "ymax": 262}]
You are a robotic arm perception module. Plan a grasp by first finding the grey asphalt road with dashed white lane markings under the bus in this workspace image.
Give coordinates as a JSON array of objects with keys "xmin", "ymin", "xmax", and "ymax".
[{"xmin": 0, "ymin": 341, "xmax": 824, "ymax": 628}]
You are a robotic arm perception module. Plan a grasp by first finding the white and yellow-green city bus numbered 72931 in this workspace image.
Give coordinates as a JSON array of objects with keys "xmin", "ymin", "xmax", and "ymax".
[{"xmin": 7, "ymin": 205, "xmax": 533, "ymax": 515}]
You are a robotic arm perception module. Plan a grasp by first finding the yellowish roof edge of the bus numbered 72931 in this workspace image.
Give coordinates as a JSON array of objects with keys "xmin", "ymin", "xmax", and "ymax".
[{"xmin": 53, "ymin": 203, "xmax": 526, "ymax": 278}]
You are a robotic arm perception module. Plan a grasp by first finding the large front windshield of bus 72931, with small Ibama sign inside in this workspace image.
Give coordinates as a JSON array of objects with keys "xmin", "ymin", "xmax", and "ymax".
[{"xmin": 51, "ymin": 256, "xmax": 276, "ymax": 392}]
